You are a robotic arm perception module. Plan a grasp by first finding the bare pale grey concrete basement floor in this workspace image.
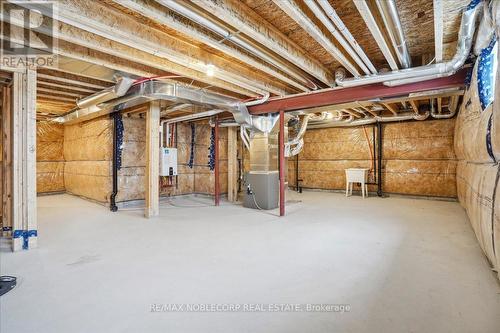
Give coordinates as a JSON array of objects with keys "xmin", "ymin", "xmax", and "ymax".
[{"xmin": 0, "ymin": 192, "xmax": 500, "ymax": 333}]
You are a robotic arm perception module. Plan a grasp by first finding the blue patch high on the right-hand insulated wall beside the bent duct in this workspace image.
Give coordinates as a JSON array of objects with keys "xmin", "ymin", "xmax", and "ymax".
[{"xmin": 477, "ymin": 34, "xmax": 497, "ymax": 111}]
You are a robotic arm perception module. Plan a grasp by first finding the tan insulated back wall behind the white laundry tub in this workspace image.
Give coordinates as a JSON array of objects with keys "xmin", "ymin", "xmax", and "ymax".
[{"xmin": 288, "ymin": 119, "xmax": 456, "ymax": 198}]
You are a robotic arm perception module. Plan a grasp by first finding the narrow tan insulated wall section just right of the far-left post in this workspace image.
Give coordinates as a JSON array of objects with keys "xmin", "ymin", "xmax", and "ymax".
[{"xmin": 36, "ymin": 121, "xmax": 65, "ymax": 193}]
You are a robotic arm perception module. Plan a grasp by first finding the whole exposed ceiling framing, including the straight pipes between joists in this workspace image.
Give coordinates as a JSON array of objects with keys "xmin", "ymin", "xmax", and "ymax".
[{"xmin": 2, "ymin": 0, "xmax": 468, "ymax": 119}]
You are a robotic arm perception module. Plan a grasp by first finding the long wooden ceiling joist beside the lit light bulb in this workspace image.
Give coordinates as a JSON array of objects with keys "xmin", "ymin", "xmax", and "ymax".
[{"xmin": 44, "ymin": 0, "xmax": 286, "ymax": 95}]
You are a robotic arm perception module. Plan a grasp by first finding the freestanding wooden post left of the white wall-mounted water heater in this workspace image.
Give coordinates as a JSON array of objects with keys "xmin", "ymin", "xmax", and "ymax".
[{"xmin": 144, "ymin": 101, "xmax": 160, "ymax": 218}]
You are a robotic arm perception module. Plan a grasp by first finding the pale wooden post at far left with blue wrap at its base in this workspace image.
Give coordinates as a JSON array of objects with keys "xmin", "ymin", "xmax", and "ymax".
[{"xmin": 12, "ymin": 69, "xmax": 37, "ymax": 251}]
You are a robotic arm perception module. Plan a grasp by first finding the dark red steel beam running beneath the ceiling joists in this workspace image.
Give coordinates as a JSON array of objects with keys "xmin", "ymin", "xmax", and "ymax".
[{"xmin": 248, "ymin": 68, "xmax": 467, "ymax": 115}]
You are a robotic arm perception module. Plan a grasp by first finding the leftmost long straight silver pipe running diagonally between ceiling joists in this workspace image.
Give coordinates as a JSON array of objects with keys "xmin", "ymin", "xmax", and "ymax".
[{"xmin": 157, "ymin": 0, "xmax": 311, "ymax": 91}]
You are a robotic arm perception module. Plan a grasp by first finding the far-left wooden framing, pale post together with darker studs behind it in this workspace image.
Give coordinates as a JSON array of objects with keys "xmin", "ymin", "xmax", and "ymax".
[{"xmin": 2, "ymin": 69, "xmax": 37, "ymax": 251}]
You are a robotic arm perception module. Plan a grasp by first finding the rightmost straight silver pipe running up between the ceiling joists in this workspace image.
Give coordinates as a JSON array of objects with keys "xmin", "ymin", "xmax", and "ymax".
[{"xmin": 377, "ymin": 0, "xmax": 411, "ymax": 68}]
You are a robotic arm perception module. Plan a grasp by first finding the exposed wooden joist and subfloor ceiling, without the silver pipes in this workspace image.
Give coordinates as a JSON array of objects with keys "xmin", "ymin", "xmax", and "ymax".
[{"xmin": 8, "ymin": 0, "xmax": 469, "ymax": 116}]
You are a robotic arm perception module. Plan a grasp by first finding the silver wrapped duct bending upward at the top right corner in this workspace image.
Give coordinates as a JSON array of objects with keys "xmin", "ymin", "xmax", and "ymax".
[{"xmin": 337, "ymin": 1, "xmax": 481, "ymax": 87}]
